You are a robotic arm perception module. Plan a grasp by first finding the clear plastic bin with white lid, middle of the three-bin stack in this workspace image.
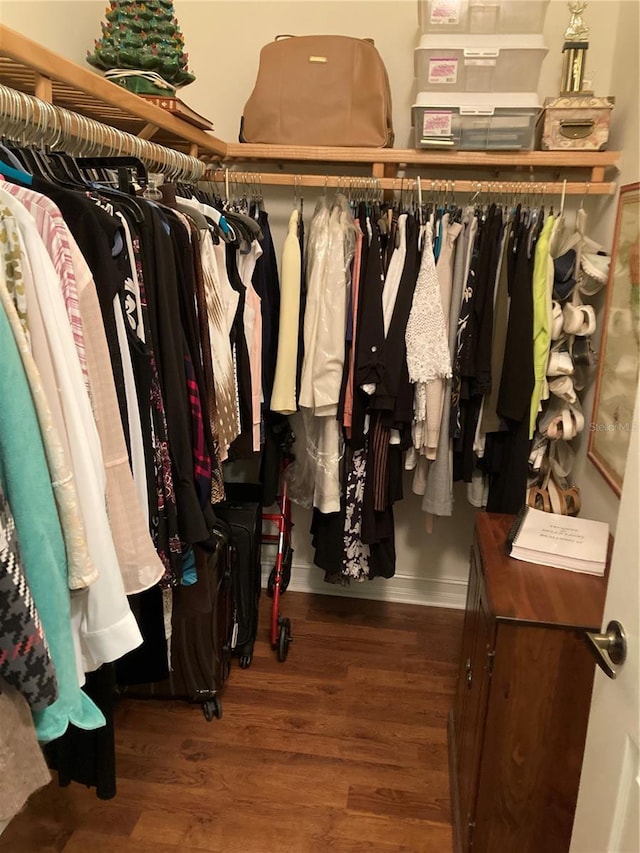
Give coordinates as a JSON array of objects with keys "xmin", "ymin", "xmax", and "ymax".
[{"xmin": 414, "ymin": 35, "xmax": 547, "ymax": 93}]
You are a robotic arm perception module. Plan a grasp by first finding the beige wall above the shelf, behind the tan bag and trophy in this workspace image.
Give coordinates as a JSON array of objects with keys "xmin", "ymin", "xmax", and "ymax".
[{"xmin": 0, "ymin": 0, "xmax": 635, "ymax": 147}]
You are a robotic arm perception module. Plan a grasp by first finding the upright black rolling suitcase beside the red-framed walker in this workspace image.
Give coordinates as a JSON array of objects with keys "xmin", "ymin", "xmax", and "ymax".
[{"xmin": 214, "ymin": 500, "xmax": 262, "ymax": 669}]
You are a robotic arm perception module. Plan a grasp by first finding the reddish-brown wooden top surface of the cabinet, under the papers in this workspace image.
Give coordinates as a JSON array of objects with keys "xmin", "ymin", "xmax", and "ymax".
[{"xmin": 476, "ymin": 512, "xmax": 612, "ymax": 630}]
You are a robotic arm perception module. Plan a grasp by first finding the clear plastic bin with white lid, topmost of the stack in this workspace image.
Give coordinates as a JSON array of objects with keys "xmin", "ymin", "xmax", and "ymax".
[{"xmin": 418, "ymin": 0, "xmax": 549, "ymax": 34}]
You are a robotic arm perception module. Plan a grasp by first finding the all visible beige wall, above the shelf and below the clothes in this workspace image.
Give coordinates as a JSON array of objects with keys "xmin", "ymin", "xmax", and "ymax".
[{"xmin": 0, "ymin": 5, "xmax": 639, "ymax": 606}]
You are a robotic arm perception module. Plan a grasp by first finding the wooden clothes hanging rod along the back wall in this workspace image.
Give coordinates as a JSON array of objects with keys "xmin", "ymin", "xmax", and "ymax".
[{"xmin": 202, "ymin": 169, "xmax": 617, "ymax": 198}]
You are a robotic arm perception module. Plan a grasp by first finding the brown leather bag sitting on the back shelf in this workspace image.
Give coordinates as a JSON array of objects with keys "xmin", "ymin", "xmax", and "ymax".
[{"xmin": 240, "ymin": 36, "xmax": 393, "ymax": 148}]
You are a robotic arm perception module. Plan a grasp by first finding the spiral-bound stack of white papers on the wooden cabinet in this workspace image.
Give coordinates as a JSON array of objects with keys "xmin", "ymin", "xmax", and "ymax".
[{"xmin": 510, "ymin": 507, "xmax": 609, "ymax": 575}]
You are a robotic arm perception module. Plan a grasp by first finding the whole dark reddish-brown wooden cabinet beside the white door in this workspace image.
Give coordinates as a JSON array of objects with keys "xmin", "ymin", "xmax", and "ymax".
[{"xmin": 449, "ymin": 513, "xmax": 606, "ymax": 853}]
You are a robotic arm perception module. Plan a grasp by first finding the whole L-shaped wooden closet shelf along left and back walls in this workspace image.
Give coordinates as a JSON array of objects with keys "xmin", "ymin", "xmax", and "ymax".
[{"xmin": 0, "ymin": 25, "xmax": 620, "ymax": 190}]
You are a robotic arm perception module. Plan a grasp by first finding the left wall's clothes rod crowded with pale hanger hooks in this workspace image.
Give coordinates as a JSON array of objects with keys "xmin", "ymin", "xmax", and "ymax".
[{"xmin": 0, "ymin": 84, "xmax": 206, "ymax": 181}]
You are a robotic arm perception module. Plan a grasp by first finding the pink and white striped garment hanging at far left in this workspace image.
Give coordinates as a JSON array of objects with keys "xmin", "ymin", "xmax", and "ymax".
[{"xmin": 0, "ymin": 181, "xmax": 89, "ymax": 391}]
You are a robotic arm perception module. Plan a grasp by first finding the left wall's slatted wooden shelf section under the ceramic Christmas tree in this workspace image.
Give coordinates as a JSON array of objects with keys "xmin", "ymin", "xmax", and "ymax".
[{"xmin": 0, "ymin": 25, "xmax": 227, "ymax": 158}]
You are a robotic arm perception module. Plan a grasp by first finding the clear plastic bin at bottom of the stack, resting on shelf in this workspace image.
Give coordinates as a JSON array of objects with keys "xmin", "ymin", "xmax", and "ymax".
[{"xmin": 412, "ymin": 92, "xmax": 540, "ymax": 151}]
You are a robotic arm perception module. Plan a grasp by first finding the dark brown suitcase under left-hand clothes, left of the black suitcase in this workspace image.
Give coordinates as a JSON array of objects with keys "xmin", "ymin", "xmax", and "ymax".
[{"xmin": 121, "ymin": 520, "xmax": 234, "ymax": 720}]
